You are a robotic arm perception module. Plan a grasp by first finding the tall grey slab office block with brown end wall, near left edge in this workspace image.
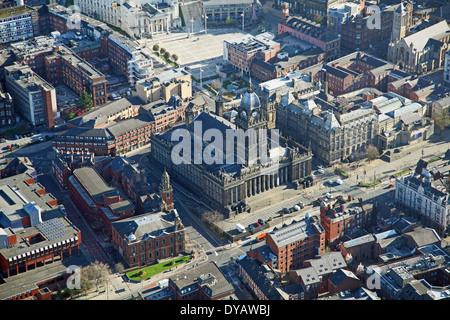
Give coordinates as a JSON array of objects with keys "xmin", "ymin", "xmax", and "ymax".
[{"xmin": 5, "ymin": 63, "xmax": 56, "ymax": 128}]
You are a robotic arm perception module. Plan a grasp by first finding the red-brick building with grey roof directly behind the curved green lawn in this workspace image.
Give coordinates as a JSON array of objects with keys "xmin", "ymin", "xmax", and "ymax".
[{"xmin": 111, "ymin": 213, "xmax": 186, "ymax": 267}]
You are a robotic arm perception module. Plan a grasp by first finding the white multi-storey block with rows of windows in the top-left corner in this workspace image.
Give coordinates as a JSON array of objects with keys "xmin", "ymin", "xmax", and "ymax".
[{"xmin": 0, "ymin": 5, "xmax": 40, "ymax": 43}]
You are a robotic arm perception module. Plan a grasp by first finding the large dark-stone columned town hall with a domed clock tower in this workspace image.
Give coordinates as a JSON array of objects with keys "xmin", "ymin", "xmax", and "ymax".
[{"xmin": 152, "ymin": 86, "xmax": 312, "ymax": 214}]
